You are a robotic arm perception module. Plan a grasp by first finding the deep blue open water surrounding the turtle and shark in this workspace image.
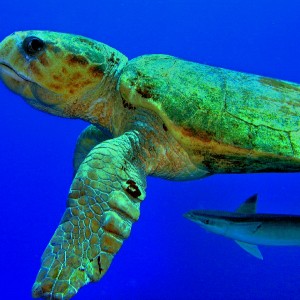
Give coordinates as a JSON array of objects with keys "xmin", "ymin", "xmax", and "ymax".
[{"xmin": 0, "ymin": 0, "xmax": 300, "ymax": 300}]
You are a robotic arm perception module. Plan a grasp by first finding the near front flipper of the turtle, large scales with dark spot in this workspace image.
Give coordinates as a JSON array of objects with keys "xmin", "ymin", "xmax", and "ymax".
[{"xmin": 32, "ymin": 132, "xmax": 146, "ymax": 300}]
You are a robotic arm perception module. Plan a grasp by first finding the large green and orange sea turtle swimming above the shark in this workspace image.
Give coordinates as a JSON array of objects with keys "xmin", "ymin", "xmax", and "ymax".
[{"xmin": 0, "ymin": 31, "xmax": 300, "ymax": 299}]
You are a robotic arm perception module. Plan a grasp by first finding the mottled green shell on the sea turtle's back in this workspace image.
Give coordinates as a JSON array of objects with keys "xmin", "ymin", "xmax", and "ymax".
[{"xmin": 119, "ymin": 55, "xmax": 300, "ymax": 157}]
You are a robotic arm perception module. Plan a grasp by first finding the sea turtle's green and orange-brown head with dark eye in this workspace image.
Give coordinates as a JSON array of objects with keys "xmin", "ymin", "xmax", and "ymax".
[{"xmin": 0, "ymin": 31, "xmax": 127, "ymax": 119}]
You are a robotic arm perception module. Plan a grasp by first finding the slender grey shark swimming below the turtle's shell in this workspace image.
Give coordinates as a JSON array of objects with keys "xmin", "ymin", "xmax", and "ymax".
[{"xmin": 184, "ymin": 194, "xmax": 300, "ymax": 260}]
